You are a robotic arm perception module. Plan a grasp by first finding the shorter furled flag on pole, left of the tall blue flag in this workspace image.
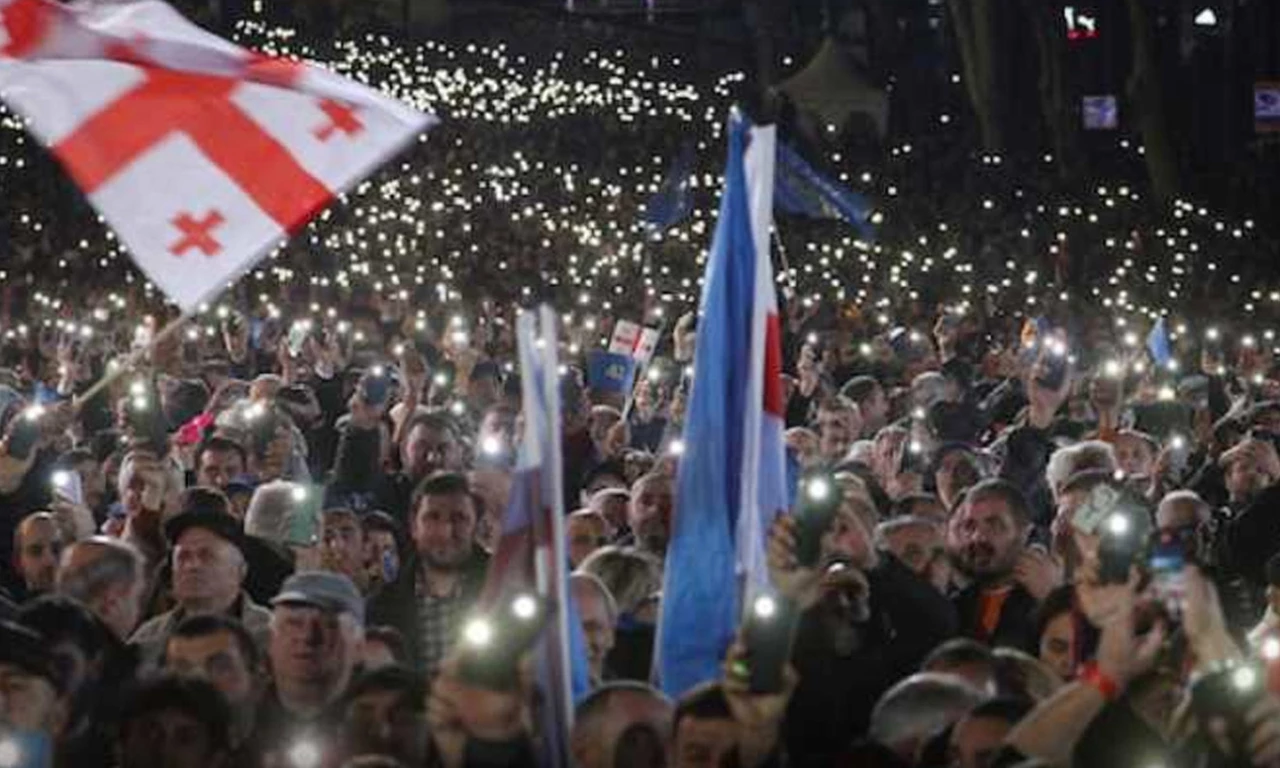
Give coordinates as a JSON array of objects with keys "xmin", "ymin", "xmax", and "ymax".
[{"xmin": 479, "ymin": 306, "xmax": 590, "ymax": 765}]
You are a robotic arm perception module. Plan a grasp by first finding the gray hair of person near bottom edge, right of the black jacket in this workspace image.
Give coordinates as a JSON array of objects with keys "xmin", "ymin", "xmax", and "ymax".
[{"xmin": 868, "ymin": 672, "xmax": 984, "ymax": 748}]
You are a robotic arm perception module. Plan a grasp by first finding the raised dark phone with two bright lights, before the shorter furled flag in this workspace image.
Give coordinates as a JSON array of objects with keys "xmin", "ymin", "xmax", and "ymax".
[{"xmin": 458, "ymin": 593, "xmax": 552, "ymax": 691}]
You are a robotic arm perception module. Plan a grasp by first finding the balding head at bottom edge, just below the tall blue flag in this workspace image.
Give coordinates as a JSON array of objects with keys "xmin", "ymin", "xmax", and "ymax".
[{"xmin": 570, "ymin": 682, "xmax": 675, "ymax": 768}]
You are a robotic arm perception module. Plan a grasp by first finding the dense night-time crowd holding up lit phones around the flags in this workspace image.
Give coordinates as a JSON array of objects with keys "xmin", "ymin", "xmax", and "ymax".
[{"xmin": 0, "ymin": 4, "xmax": 1280, "ymax": 768}]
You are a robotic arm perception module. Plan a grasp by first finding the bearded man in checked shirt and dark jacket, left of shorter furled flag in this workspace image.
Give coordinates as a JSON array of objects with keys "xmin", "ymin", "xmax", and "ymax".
[{"xmin": 369, "ymin": 472, "xmax": 489, "ymax": 678}]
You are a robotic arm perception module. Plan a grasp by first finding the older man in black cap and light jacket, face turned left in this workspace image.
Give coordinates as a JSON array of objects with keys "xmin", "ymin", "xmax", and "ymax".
[{"xmin": 129, "ymin": 512, "xmax": 271, "ymax": 666}]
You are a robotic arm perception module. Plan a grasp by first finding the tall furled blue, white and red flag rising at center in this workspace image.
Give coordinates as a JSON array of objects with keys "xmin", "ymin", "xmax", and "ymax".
[{"xmin": 655, "ymin": 113, "xmax": 787, "ymax": 696}]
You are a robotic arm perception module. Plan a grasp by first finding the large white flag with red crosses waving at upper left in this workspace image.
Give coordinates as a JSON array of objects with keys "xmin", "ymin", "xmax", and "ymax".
[{"xmin": 0, "ymin": 0, "xmax": 435, "ymax": 311}]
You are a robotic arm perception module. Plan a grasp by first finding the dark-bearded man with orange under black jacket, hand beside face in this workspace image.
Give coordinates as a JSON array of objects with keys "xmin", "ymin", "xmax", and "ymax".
[{"xmin": 948, "ymin": 480, "xmax": 1061, "ymax": 650}]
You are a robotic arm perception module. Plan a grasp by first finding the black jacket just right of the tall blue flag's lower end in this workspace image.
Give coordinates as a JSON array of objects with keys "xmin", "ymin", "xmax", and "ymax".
[{"xmin": 783, "ymin": 556, "xmax": 956, "ymax": 765}]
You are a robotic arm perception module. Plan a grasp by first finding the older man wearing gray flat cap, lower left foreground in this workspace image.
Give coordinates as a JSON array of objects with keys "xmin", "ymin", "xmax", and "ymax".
[{"xmin": 250, "ymin": 571, "xmax": 365, "ymax": 764}]
